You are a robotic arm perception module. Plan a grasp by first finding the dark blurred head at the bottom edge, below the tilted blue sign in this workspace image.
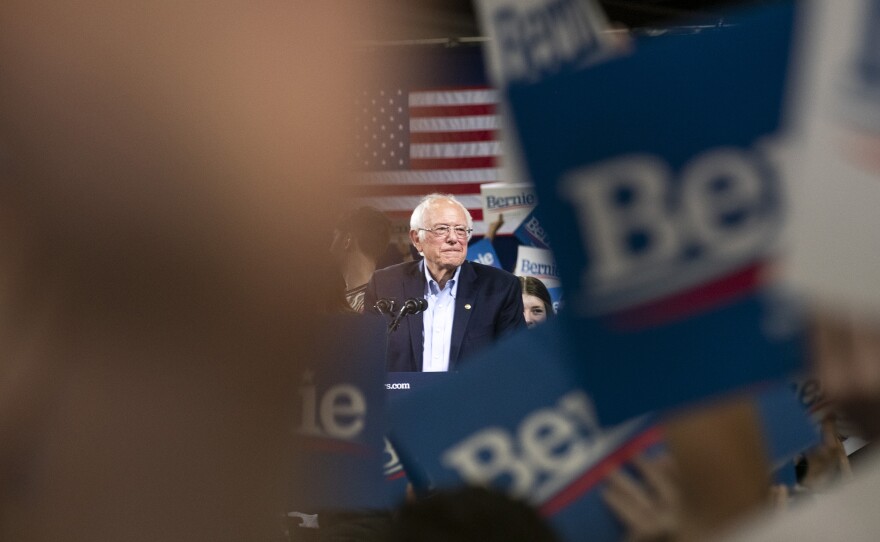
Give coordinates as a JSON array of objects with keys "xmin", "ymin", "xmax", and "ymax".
[{"xmin": 388, "ymin": 487, "xmax": 559, "ymax": 542}]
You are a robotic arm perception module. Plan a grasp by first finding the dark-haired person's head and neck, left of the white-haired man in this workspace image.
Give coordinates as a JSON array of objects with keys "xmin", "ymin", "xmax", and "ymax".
[{"xmin": 330, "ymin": 206, "xmax": 391, "ymax": 312}]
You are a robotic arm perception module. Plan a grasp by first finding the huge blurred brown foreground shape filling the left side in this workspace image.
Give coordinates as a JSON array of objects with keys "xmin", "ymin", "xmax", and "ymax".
[{"xmin": 0, "ymin": 0, "xmax": 382, "ymax": 540}]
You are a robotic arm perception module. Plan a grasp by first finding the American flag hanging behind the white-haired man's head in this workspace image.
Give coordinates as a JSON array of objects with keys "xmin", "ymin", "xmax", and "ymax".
[{"xmin": 355, "ymin": 86, "xmax": 502, "ymax": 235}]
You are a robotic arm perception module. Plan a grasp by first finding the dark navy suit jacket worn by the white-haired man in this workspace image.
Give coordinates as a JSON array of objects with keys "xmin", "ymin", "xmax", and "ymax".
[{"xmin": 364, "ymin": 260, "xmax": 526, "ymax": 371}]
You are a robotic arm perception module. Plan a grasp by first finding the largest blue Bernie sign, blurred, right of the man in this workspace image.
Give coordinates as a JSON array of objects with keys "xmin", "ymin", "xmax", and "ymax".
[{"xmin": 508, "ymin": 3, "xmax": 802, "ymax": 423}]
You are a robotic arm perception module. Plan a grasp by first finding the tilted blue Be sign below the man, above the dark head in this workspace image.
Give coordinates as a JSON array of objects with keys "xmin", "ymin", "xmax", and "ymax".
[{"xmin": 389, "ymin": 323, "xmax": 661, "ymax": 541}]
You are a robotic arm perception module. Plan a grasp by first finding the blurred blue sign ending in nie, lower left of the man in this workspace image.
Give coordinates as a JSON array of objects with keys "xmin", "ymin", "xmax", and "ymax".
[{"xmin": 288, "ymin": 315, "xmax": 390, "ymax": 513}]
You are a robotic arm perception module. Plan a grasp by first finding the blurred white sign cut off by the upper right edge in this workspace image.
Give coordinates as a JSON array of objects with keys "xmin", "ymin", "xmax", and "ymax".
[{"xmin": 784, "ymin": 0, "xmax": 880, "ymax": 317}]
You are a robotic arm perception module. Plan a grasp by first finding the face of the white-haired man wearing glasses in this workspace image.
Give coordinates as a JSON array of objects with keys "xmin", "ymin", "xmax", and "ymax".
[{"xmin": 410, "ymin": 200, "xmax": 468, "ymax": 276}]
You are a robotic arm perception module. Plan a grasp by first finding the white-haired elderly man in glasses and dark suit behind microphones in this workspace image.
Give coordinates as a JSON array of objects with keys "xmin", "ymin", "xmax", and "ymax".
[{"xmin": 364, "ymin": 194, "xmax": 525, "ymax": 372}]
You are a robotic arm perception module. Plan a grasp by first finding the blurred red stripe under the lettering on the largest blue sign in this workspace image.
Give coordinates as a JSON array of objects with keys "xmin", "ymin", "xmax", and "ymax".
[{"xmin": 609, "ymin": 262, "xmax": 765, "ymax": 330}]
